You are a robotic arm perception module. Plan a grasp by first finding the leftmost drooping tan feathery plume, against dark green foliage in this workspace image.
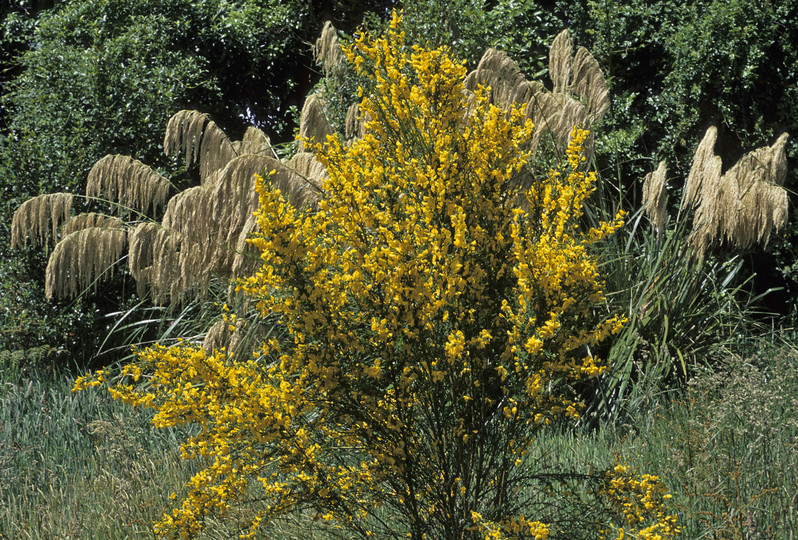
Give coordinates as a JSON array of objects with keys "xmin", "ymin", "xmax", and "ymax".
[{"xmin": 11, "ymin": 193, "xmax": 72, "ymax": 249}]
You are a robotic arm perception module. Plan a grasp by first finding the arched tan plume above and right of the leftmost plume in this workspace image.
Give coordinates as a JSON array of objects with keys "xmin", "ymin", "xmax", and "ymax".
[{"xmin": 86, "ymin": 154, "xmax": 171, "ymax": 213}]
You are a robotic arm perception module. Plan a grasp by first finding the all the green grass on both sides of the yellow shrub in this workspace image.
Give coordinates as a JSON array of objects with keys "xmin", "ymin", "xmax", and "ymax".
[{"xmin": 0, "ymin": 345, "xmax": 798, "ymax": 540}]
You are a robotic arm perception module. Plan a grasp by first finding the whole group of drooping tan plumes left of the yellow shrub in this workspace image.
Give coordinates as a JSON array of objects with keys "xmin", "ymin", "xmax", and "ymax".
[{"xmin": 12, "ymin": 105, "xmax": 322, "ymax": 307}]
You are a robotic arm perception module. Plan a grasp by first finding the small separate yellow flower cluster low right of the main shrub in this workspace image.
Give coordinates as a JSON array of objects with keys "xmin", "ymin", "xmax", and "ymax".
[{"xmin": 600, "ymin": 464, "xmax": 680, "ymax": 540}]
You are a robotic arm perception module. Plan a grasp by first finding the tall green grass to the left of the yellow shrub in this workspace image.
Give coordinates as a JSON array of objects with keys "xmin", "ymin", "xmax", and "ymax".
[{"xmin": 0, "ymin": 358, "xmax": 198, "ymax": 539}]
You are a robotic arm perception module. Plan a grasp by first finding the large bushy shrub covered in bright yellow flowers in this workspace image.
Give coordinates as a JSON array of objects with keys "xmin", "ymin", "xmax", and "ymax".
[{"xmin": 73, "ymin": 15, "xmax": 636, "ymax": 540}]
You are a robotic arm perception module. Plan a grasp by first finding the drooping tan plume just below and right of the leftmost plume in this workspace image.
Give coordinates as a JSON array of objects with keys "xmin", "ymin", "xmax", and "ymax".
[{"xmin": 44, "ymin": 227, "xmax": 127, "ymax": 300}]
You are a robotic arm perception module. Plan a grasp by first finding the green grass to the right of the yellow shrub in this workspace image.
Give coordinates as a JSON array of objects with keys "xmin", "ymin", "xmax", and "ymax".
[{"xmin": 567, "ymin": 345, "xmax": 798, "ymax": 540}]
